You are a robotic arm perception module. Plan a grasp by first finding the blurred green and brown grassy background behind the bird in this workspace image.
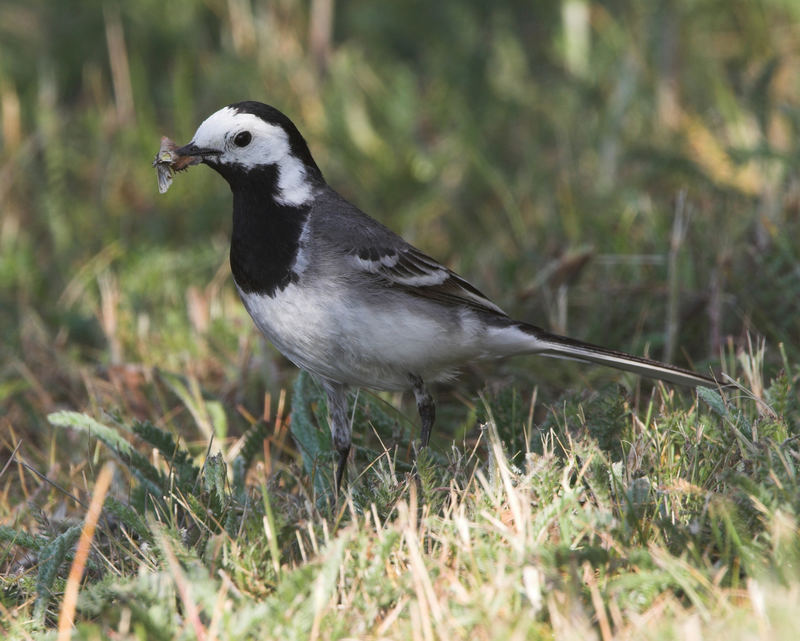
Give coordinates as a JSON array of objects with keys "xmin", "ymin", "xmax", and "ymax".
[{"xmin": 0, "ymin": 0, "xmax": 800, "ymax": 450}]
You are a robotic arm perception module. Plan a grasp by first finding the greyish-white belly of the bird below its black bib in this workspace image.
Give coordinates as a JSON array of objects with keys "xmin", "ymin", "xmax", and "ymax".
[{"xmin": 234, "ymin": 284, "xmax": 485, "ymax": 390}]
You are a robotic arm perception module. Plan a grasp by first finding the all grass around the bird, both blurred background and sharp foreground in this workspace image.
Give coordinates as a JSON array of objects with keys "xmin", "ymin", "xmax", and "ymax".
[{"xmin": 0, "ymin": 0, "xmax": 800, "ymax": 641}]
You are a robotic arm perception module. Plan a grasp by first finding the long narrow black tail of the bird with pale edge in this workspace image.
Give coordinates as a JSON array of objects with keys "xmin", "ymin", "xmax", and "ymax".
[{"xmin": 518, "ymin": 323, "xmax": 718, "ymax": 387}]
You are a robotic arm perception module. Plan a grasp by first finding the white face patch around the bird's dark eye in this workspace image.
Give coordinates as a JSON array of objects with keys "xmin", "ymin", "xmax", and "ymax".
[{"xmin": 192, "ymin": 107, "xmax": 313, "ymax": 206}]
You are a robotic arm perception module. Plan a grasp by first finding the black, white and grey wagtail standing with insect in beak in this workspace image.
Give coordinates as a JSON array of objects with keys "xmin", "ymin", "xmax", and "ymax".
[{"xmin": 166, "ymin": 101, "xmax": 716, "ymax": 493}]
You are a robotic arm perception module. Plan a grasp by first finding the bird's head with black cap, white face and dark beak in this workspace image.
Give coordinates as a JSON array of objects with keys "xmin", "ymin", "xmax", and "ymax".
[{"xmin": 174, "ymin": 101, "xmax": 323, "ymax": 206}]
